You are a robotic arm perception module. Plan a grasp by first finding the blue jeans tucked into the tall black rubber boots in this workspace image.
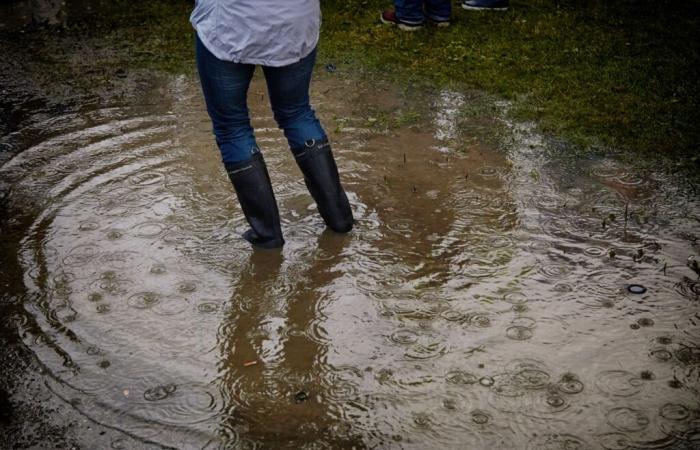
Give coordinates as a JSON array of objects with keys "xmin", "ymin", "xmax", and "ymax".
[{"xmin": 196, "ymin": 37, "xmax": 326, "ymax": 165}]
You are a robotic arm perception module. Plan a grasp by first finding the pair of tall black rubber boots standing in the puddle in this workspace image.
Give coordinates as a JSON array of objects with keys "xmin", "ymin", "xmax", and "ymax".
[{"xmin": 226, "ymin": 139, "xmax": 354, "ymax": 248}]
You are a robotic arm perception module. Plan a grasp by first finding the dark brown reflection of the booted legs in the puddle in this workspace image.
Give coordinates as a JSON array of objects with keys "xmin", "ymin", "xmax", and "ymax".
[{"xmin": 220, "ymin": 232, "xmax": 361, "ymax": 448}]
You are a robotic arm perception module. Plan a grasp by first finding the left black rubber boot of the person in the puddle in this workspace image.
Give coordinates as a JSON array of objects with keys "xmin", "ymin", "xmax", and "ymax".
[{"xmin": 226, "ymin": 152, "xmax": 284, "ymax": 248}]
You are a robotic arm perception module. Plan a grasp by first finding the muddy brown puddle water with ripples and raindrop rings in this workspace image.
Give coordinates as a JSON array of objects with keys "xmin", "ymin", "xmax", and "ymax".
[{"xmin": 0, "ymin": 72, "xmax": 700, "ymax": 449}]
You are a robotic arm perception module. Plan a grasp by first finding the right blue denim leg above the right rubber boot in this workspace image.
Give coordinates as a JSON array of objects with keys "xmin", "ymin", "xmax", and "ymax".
[{"xmin": 263, "ymin": 49, "xmax": 326, "ymax": 149}]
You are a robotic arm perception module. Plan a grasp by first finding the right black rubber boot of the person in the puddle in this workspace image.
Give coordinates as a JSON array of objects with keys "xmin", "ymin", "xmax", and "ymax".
[{"xmin": 292, "ymin": 139, "xmax": 354, "ymax": 233}]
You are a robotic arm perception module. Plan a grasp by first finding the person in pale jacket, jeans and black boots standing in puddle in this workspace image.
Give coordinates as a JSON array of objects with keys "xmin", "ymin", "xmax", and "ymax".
[{"xmin": 190, "ymin": 0, "xmax": 354, "ymax": 248}]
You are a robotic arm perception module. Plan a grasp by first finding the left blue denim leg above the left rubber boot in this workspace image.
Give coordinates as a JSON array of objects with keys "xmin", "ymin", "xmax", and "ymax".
[{"xmin": 196, "ymin": 37, "xmax": 258, "ymax": 165}]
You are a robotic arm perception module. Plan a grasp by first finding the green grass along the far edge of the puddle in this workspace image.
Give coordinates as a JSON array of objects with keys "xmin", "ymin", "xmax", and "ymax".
[{"xmin": 6, "ymin": 0, "xmax": 700, "ymax": 164}]
